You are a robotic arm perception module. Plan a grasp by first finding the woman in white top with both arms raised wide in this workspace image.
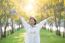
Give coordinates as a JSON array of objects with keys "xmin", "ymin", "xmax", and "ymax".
[{"xmin": 20, "ymin": 17, "xmax": 46, "ymax": 43}]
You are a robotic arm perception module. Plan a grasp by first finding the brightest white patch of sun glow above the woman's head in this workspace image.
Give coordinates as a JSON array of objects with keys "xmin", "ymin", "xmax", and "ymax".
[{"xmin": 23, "ymin": 0, "xmax": 35, "ymax": 12}]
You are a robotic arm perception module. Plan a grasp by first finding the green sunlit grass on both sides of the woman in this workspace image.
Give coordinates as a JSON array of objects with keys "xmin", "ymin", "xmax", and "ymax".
[{"xmin": 0, "ymin": 29, "xmax": 65, "ymax": 43}]
